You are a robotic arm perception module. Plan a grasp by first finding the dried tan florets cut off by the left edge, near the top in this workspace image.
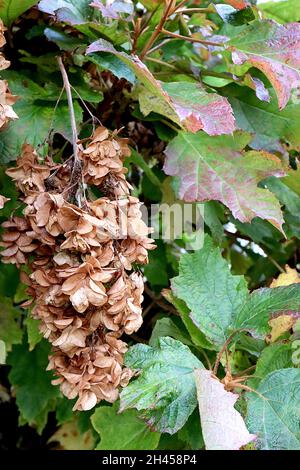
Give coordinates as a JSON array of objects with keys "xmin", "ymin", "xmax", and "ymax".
[{"xmin": 0, "ymin": 19, "xmax": 18, "ymax": 129}]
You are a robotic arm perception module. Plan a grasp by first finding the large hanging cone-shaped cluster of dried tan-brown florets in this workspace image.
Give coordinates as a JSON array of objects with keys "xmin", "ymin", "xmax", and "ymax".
[{"xmin": 1, "ymin": 127, "xmax": 154, "ymax": 410}]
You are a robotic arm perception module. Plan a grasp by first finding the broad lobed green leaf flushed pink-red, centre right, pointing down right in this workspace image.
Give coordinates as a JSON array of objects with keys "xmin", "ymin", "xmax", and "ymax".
[{"xmin": 164, "ymin": 131, "xmax": 285, "ymax": 230}]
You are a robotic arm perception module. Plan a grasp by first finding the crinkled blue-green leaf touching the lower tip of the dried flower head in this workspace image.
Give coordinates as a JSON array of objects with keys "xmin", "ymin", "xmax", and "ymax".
[{"xmin": 120, "ymin": 337, "xmax": 203, "ymax": 434}]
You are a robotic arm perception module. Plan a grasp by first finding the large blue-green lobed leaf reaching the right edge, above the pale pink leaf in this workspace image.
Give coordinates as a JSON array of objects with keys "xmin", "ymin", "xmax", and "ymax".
[{"xmin": 172, "ymin": 235, "xmax": 300, "ymax": 347}]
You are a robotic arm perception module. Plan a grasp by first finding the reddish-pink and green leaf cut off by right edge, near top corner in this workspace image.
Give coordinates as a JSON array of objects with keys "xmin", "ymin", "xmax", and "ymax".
[{"xmin": 227, "ymin": 20, "xmax": 300, "ymax": 109}]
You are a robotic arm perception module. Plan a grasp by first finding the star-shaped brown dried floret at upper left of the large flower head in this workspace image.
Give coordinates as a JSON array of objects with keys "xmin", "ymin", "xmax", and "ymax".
[{"xmin": 6, "ymin": 144, "xmax": 54, "ymax": 194}]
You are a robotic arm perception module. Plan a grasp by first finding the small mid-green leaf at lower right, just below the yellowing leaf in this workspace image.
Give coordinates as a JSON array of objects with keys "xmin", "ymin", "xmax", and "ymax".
[{"xmin": 247, "ymin": 343, "xmax": 293, "ymax": 389}]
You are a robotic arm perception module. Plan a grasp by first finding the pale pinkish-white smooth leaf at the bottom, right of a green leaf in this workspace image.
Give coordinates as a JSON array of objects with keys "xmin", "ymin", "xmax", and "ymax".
[{"xmin": 194, "ymin": 369, "xmax": 256, "ymax": 450}]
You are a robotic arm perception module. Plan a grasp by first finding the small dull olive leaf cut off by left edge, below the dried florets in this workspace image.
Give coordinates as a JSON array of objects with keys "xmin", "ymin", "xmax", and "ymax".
[{"xmin": 0, "ymin": 297, "xmax": 23, "ymax": 352}]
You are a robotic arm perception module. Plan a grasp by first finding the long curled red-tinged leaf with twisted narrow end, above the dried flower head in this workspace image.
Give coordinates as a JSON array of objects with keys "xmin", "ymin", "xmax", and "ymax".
[{"xmin": 87, "ymin": 39, "xmax": 235, "ymax": 135}]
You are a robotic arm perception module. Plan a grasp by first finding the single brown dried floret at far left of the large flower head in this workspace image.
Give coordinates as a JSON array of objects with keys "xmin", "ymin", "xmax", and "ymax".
[{"xmin": 0, "ymin": 217, "xmax": 38, "ymax": 267}]
